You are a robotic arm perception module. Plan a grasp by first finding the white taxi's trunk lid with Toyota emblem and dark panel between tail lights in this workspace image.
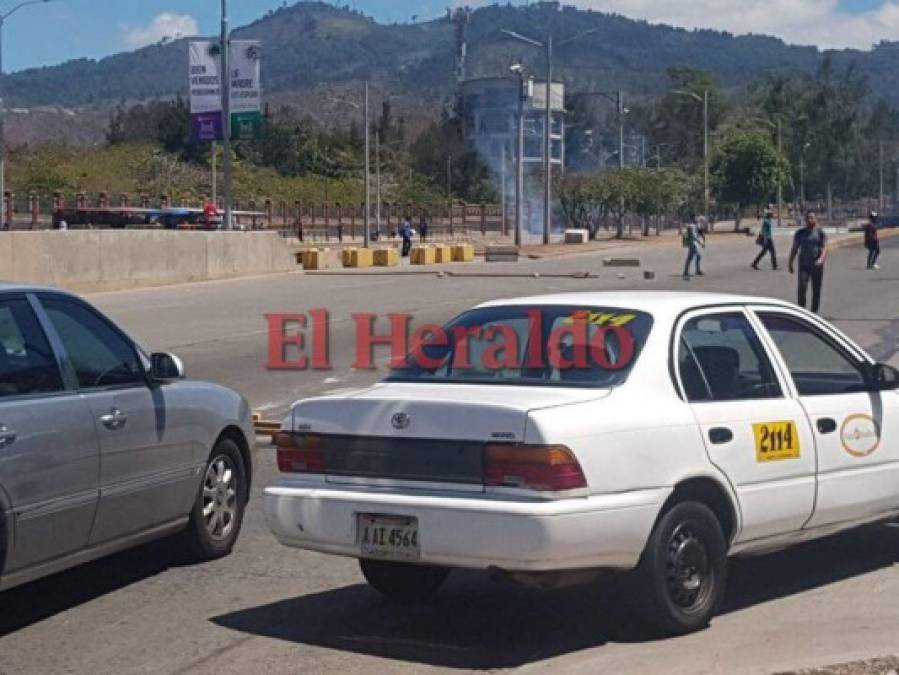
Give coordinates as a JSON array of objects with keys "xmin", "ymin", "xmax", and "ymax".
[{"xmin": 292, "ymin": 383, "xmax": 609, "ymax": 491}]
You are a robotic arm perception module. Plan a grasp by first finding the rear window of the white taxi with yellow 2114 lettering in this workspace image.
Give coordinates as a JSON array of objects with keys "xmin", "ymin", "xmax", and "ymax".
[{"xmin": 386, "ymin": 306, "xmax": 652, "ymax": 388}]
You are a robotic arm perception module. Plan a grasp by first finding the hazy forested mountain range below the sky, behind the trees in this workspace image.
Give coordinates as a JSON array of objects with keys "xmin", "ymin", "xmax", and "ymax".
[{"xmin": 2, "ymin": 2, "xmax": 899, "ymax": 143}]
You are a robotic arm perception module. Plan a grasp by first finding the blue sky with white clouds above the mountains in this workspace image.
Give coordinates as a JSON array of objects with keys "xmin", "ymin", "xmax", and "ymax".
[{"xmin": 0, "ymin": 0, "xmax": 899, "ymax": 72}]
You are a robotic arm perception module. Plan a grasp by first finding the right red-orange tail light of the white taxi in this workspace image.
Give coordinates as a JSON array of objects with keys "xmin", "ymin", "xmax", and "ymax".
[{"xmin": 484, "ymin": 444, "xmax": 587, "ymax": 492}]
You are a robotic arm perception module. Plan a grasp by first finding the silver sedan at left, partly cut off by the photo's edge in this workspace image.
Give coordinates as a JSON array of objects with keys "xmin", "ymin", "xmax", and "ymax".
[{"xmin": 0, "ymin": 285, "xmax": 255, "ymax": 590}]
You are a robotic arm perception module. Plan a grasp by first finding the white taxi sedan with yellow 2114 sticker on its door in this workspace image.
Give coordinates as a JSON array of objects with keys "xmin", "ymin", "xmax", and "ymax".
[{"xmin": 265, "ymin": 293, "xmax": 899, "ymax": 634}]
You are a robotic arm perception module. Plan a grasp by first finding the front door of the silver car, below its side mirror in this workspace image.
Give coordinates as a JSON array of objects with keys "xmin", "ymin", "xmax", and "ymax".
[{"xmin": 40, "ymin": 295, "xmax": 200, "ymax": 544}]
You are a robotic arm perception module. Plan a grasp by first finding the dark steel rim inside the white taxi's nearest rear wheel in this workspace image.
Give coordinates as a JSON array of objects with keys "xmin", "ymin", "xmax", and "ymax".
[{"xmin": 665, "ymin": 522, "xmax": 714, "ymax": 613}]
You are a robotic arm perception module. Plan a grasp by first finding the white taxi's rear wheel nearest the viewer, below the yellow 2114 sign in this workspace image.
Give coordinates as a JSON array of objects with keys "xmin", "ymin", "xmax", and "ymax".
[{"xmin": 631, "ymin": 502, "xmax": 727, "ymax": 636}]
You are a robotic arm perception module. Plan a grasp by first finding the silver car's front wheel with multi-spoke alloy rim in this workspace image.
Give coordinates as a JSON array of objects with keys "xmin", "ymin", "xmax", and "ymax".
[{"xmin": 183, "ymin": 438, "xmax": 248, "ymax": 562}]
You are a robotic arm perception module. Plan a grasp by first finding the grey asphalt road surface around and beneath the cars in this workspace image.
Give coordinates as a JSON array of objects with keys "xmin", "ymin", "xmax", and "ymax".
[{"xmin": 0, "ymin": 237, "xmax": 899, "ymax": 674}]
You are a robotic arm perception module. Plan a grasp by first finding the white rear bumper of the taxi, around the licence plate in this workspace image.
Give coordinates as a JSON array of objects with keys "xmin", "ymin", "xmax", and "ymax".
[{"xmin": 264, "ymin": 484, "xmax": 671, "ymax": 572}]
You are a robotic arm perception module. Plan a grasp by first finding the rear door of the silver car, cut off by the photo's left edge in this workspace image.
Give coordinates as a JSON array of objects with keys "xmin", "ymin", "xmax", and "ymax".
[{"xmin": 0, "ymin": 294, "xmax": 99, "ymax": 573}]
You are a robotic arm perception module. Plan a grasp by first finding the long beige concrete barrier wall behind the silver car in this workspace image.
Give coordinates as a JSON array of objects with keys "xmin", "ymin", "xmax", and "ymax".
[{"xmin": 0, "ymin": 230, "xmax": 297, "ymax": 292}]
